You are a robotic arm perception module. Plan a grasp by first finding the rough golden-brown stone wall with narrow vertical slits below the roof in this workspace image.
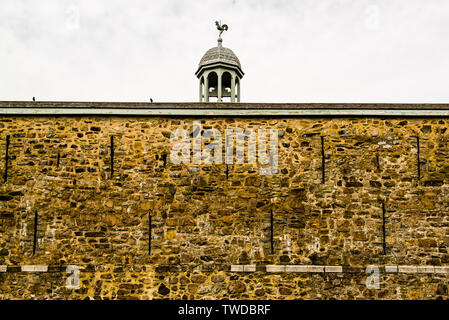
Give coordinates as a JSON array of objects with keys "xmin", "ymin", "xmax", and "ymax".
[{"xmin": 0, "ymin": 116, "xmax": 449, "ymax": 299}]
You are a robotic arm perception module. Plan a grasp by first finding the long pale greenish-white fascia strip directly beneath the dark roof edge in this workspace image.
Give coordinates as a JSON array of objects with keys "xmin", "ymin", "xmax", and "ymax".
[{"xmin": 0, "ymin": 108, "xmax": 449, "ymax": 117}]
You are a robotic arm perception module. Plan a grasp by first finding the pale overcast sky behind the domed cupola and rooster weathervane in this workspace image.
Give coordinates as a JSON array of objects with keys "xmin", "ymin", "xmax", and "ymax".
[{"xmin": 0, "ymin": 0, "xmax": 449, "ymax": 103}]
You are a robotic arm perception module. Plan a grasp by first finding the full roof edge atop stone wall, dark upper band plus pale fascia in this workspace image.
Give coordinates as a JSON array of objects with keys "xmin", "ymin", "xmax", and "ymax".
[{"xmin": 0, "ymin": 101, "xmax": 449, "ymax": 117}]
